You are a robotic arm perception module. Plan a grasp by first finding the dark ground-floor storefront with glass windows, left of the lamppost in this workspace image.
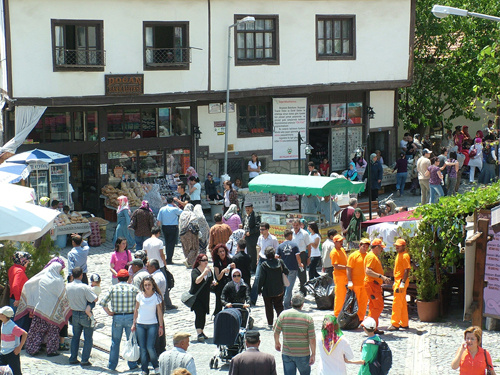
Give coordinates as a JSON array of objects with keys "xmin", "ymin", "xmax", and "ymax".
[{"xmin": 8, "ymin": 104, "xmax": 196, "ymax": 213}]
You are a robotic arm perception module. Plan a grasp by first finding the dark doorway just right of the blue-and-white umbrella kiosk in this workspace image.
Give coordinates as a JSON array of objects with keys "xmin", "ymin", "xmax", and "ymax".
[{"xmin": 69, "ymin": 154, "xmax": 100, "ymax": 215}]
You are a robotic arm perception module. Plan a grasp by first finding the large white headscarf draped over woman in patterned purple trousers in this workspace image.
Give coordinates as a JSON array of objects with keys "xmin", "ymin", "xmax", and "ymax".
[{"xmin": 15, "ymin": 262, "xmax": 71, "ymax": 328}]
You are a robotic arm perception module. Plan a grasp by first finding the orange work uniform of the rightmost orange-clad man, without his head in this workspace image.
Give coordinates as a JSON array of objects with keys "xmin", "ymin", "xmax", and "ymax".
[{"xmin": 391, "ymin": 251, "xmax": 411, "ymax": 327}]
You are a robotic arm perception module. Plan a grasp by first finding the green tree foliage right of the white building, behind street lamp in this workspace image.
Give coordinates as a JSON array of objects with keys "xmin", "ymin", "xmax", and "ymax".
[{"xmin": 399, "ymin": 0, "xmax": 500, "ymax": 133}]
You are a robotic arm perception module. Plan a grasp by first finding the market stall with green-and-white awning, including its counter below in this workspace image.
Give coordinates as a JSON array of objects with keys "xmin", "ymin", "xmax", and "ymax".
[{"xmin": 248, "ymin": 174, "xmax": 365, "ymax": 241}]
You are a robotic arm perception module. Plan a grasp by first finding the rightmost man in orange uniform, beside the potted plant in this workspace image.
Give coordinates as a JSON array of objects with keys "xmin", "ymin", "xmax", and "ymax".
[{"xmin": 388, "ymin": 238, "xmax": 411, "ymax": 331}]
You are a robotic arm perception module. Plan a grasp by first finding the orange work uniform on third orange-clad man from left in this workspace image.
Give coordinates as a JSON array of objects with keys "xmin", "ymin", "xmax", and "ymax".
[{"xmin": 364, "ymin": 251, "xmax": 384, "ymax": 327}]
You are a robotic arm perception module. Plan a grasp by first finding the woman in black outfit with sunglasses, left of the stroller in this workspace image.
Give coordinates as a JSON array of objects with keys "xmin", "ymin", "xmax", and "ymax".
[{"xmin": 189, "ymin": 254, "xmax": 214, "ymax": 342}]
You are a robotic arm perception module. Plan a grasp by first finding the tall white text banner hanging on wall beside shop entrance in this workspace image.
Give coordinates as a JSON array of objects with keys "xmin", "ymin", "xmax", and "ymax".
[{"xmin": 273, "ymin": 98, "xmax": 307, "ymax": 160}]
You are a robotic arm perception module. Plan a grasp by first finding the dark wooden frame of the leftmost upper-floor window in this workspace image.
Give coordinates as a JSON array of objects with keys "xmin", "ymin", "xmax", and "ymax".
[{"xmin": 51, "ymin": 19, "xmax": 106, "ymax": 72}]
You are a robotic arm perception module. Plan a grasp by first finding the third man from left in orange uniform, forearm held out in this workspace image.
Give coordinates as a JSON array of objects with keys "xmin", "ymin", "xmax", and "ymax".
[{"xmin": 365, "ymin": 238, "xmax": 391, "ymax": 335}]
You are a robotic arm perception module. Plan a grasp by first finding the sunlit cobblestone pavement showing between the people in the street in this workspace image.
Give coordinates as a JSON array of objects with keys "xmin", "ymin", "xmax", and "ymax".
[{"xmin": 21, "ymin": 184, "xmax": 500, "ymax": 375}]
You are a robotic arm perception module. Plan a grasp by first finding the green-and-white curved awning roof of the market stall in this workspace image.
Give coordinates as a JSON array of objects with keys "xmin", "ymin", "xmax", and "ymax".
[{"xmin": 248, "ymin": 174, "xmax": 365, "ymax": 197}]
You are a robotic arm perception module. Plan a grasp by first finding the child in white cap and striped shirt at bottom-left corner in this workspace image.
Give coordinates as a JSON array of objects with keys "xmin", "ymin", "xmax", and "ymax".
[{"xmin": 0, "ymin": 306, "xmax": 28, "ymax": 375}]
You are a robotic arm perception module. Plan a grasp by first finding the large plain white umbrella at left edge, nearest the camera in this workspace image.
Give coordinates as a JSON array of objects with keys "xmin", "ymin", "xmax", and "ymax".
[{"xmin": 0, "ymin": 200, "xmax": 60, "ymax": 241}]
